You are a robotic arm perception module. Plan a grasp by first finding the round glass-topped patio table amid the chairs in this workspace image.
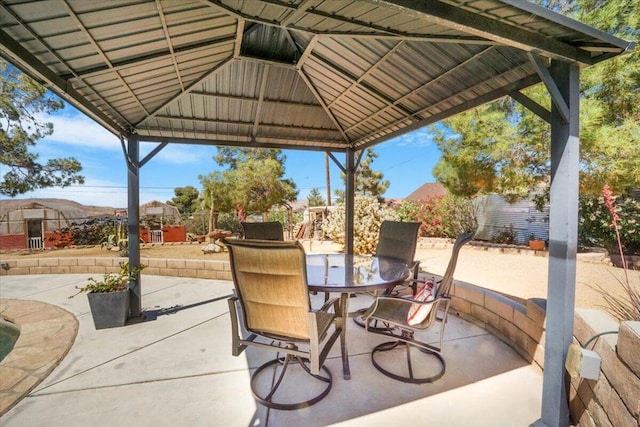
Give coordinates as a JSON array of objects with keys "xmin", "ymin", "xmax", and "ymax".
[{"xmin": 307, "ymin": 254, "xmax": 411, "ymax": 380}]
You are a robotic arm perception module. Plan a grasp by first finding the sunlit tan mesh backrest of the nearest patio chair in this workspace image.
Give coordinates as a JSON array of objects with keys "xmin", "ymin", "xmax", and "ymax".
[{"xmin": 223, "ymin": 239, "xmax": 310, "ymax": 339}]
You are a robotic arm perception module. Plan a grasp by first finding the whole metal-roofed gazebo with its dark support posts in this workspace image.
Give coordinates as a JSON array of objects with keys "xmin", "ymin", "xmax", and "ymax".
[{"xmin": 0, "ymin": 0, "xmax": 633, "ymax": 426}]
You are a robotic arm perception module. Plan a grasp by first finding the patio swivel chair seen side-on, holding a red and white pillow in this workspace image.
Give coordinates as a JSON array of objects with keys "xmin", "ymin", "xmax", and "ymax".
[{"xmin": 364, "ymin": 233, "xmax": 473, "ymax": 384}]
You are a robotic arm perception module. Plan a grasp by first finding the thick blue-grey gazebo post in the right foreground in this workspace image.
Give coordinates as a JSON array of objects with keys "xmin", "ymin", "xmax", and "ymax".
[{"xmin": 534, "ymin": 60, "xmax": 580, "ymax": 427}]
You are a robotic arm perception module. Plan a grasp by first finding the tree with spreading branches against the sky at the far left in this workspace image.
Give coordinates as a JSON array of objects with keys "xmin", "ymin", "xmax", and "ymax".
[{"xmin": 0, "ymin": 59, "xmax": 84, "ymax": 197}]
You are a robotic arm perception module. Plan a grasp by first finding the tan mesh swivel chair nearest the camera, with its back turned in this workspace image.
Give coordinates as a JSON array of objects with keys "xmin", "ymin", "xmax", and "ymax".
[{"xmin": 223, "ymin": 239, "xmax": 342, "ymax": 410}]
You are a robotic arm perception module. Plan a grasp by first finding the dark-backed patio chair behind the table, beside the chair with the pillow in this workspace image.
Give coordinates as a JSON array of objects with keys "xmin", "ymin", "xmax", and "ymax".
[{"xmin": 353, "ymin": 221, "xmax": 421, "ymax": 328}]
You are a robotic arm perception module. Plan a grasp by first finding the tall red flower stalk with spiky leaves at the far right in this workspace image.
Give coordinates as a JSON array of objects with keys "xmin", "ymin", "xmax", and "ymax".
[{"xmin": 597, "ymin": 185, "xmax": 640, "ymax": 321}]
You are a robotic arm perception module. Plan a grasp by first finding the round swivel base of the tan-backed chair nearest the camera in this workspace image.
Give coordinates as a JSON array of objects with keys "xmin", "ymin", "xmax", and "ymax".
[{"xmin": 251, "ymin": 354, "xmax": 333, "ymax": 411}]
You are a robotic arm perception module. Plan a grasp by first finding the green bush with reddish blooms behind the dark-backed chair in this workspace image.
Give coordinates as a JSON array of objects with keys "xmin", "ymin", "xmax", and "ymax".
[{"xmin": 398, "ymin": 195, "xmax": 478, "ymax": 239}]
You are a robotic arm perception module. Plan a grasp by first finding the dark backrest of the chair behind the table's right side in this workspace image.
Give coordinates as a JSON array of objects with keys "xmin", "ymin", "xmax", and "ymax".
[{"xmin": 376, "ymin": 221, "xmax": 420, "ymax": 265}]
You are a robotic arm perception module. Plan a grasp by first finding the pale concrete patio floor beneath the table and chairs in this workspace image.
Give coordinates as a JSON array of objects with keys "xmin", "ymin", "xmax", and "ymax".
[{"xmin": 0, "ymin": 274, "xmax": 542, "ymax": 427}]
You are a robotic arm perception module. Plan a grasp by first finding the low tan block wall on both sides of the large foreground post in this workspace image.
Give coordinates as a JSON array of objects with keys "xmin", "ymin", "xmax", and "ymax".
[{"xmin": 451, "ymin": 282, "xmax": 640, "ymax": 427}]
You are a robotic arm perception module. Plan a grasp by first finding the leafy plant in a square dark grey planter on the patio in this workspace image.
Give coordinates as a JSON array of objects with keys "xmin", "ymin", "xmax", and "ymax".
[{"xmin": 69, "ymin": 262, "xmax": 146, "ymax": 329}]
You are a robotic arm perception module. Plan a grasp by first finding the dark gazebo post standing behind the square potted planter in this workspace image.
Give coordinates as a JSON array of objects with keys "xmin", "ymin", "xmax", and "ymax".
[{"xmin": 125, "ymin": 133, "xmax": 142, "ymax": 317}]
